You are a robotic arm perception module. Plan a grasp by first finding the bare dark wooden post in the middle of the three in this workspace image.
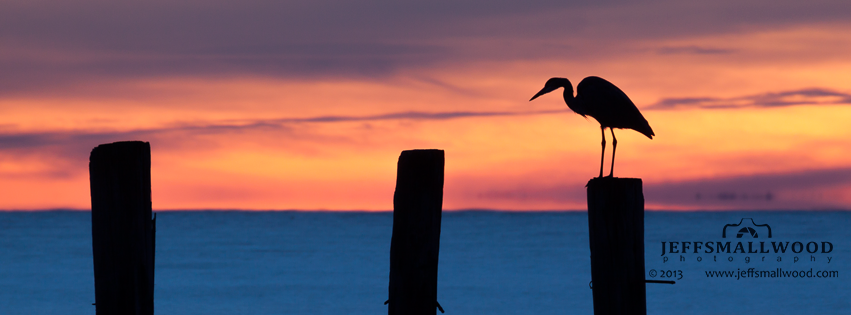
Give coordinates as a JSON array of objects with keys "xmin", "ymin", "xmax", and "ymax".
[{"xmin": 385, "ymin": 150, "xmax": 444, "ymax": 315}]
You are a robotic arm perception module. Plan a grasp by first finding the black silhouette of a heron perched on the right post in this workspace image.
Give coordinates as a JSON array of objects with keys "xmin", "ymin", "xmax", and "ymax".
[{"xmin": 529, "ymin": 77, "xmax": 656, "ymax": 177}]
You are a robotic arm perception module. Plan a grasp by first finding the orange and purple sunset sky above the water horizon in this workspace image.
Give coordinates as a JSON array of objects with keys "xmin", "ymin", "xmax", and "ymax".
[{"xmin": 0, "ymin": 0, "xmax": 851, "ymax": 210}]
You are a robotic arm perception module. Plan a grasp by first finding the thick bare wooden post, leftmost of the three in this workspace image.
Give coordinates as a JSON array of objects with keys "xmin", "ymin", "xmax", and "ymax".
[{"xmin": 89, "ymin": 141, "xmax": 156, "ymax": 315}]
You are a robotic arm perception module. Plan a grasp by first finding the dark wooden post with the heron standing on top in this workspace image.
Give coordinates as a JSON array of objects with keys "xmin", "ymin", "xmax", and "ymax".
[{"xmin": 587, "ymin": 177, "xmax": 647, "ymax": 315}]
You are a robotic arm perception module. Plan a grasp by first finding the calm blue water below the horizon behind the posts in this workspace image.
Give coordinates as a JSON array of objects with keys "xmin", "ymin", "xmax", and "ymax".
[{"xmin": 0, "ymin": 211, "xmax": 851, "ymax": 315}]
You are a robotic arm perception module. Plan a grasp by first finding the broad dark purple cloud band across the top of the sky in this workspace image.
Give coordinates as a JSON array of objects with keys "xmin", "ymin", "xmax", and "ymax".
[{"xmin": 0, "ymin": 0, "xmax": 851, "ymax": 94}]
